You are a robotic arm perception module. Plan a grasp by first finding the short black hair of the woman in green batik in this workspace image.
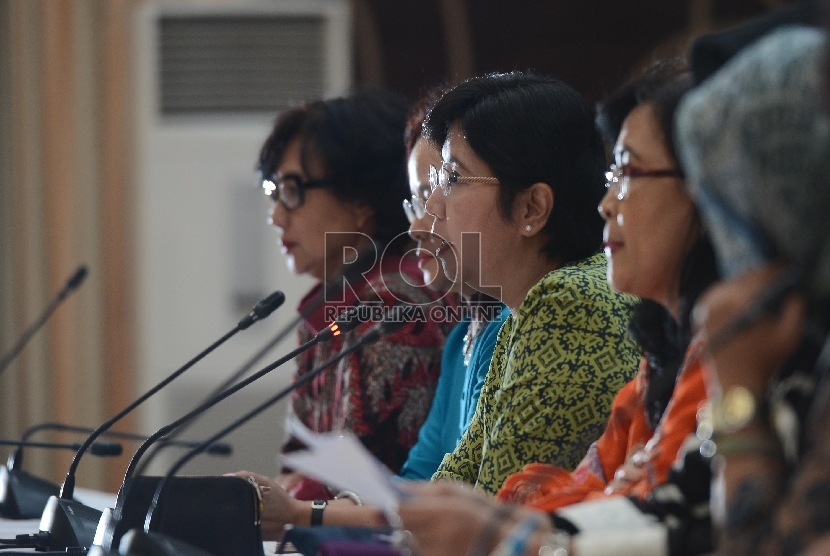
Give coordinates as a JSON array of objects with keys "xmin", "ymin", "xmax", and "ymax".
[{"xmin": 424, "ymin": 71, "xmax": 605, "ymax": 263}]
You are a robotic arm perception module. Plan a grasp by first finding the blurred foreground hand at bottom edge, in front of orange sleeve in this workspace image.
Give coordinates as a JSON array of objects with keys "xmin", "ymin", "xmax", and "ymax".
[{"xmin": 399, "ymin": 481, "xmax": 549, "ymax": 556}]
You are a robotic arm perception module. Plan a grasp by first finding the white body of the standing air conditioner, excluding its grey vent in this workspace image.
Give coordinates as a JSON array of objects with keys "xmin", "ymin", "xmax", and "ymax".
[{"xmin": 136, "ymin": 2, "xmax": 350, "ymax": 474}]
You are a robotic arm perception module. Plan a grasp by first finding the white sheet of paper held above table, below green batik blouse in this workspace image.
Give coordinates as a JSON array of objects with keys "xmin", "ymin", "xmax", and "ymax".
[{"xmin": 283, "ymin": 419, "xmax": 405, "ymax": 514}]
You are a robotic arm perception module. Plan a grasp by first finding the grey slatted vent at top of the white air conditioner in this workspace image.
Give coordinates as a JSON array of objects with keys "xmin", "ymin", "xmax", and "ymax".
[{"xmin": 158, "ymin": 15, "xmax": 326, "ymax": 116}]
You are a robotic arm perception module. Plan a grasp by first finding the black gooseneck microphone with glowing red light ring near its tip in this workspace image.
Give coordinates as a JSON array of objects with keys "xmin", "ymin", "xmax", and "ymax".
[{"xmin": 93, "ymin": 306, "xmax": 370, "ymax": 550}]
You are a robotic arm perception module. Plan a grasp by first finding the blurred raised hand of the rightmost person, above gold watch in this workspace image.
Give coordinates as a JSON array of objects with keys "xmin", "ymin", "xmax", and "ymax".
[{"xmin": 694, "ymin": 265, "xmax": 804, "ymax": 397}]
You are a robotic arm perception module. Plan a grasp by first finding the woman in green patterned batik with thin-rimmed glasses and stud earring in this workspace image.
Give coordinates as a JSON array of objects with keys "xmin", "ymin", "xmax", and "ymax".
[{"xmin": 424, "ymin": 72, "xmax": 639, "ymax": 494}]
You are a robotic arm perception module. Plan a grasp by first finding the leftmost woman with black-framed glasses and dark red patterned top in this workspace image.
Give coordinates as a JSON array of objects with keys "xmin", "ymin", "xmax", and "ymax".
[{"xmin": 234, "ymin": 91, "xmax": 456, "ymax": 515}]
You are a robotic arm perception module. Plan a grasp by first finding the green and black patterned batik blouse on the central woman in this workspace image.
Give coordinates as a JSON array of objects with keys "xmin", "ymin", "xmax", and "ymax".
[{"xmin": 432, "ymin": 255, "xmax": 640, "ymax": 494}]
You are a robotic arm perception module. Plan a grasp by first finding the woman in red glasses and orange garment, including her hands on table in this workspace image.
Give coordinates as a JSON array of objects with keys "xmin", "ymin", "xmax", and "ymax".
[{"xmin": 401, "ymin": 61, "xmax": 717, "ymax": 555}]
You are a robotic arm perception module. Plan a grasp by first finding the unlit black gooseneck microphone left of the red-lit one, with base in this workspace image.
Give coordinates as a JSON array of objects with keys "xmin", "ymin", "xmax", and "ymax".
[{"xmin": 40, "ymin": 291, "xmax": 285, "ymax": 550}]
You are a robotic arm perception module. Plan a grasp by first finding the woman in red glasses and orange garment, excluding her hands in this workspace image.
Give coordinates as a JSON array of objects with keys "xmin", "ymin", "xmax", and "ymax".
[{"xmin": 498, "ymin": 62, "xmax": 716, "ymax": 512}]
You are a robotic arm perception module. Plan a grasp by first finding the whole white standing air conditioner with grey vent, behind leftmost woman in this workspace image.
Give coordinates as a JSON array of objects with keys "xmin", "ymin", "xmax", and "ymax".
[{"xmin": 134, "ymin": 0, "xmax": 353, "ymax": 478}]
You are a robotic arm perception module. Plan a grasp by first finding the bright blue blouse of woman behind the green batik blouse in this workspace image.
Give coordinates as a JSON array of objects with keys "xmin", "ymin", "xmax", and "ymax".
[{"xmin": 399, "ymin": 307, "xmax": 510, "ymax": 480}]
